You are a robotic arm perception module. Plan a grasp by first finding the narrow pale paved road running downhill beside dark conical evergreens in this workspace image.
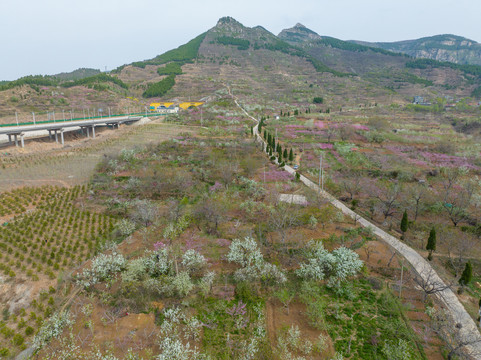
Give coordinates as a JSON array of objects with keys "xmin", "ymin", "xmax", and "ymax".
[{"xmin": 228, "ymin": 88, "xmax": 481, "ymax": 359}]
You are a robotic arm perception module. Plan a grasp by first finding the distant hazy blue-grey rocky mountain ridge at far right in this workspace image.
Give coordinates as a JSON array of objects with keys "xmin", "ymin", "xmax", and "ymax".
[{"xmin": 352, "ymin": 34, "xmax": 481, "ymax": 65}]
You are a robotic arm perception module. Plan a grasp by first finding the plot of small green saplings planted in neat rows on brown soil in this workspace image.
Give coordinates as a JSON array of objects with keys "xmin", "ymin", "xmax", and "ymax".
[{"xmin": 0, "ymin": 187, "xmax": 113, "ymax": 279}]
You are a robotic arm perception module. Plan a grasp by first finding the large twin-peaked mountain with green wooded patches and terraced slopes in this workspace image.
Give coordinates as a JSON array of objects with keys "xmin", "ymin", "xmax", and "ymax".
[{"xmin": 0, "ymin": 17, "xmax": 481, "ymax": 122}]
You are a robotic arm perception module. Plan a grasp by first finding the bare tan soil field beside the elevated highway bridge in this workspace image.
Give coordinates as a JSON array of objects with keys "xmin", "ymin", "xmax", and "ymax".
[{"xmin": 0, "ymin": 119, "xmax": 198, "ymax": 191}]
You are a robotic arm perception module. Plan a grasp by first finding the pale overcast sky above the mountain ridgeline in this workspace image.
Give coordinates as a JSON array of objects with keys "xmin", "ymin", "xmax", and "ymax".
[{"xmin": 0, "ymin": 0, "xmax": 481, "ymax": 80}]
